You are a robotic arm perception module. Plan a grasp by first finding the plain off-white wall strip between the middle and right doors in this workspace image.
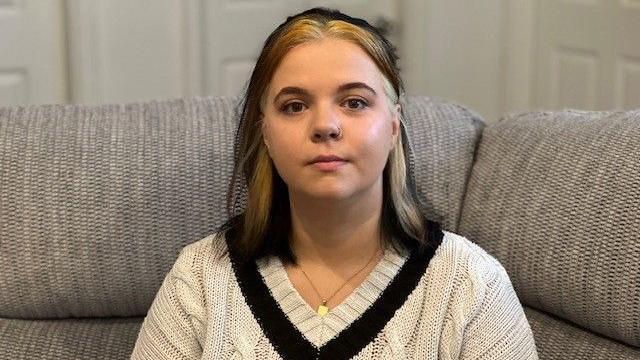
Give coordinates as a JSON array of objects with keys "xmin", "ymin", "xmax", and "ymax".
[{"xmin": 403, "ymin": 0, "xmax": 505, "ymax": 120}]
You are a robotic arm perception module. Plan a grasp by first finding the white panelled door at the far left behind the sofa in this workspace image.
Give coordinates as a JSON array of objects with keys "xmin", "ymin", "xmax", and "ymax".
[{"xmin": 0, "ymin": 0, "xmax": 67, "ymax": 106}]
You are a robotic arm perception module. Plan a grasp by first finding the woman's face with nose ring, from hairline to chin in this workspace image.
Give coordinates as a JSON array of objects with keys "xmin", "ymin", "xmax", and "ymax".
[{"xmin": 263, "ymin": 38, "xmax": 399, "ymax": 200}]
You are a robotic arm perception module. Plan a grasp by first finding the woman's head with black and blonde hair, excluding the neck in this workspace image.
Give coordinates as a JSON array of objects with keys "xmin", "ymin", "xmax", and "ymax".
[{"xmin": 224, "ymin": 8, "xmax": 425, "ymax": 262}]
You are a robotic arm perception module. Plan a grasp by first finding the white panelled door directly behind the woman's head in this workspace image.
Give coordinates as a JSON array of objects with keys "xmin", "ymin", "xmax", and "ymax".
[{"xmin": 203, "ymin": 0, "xmax": 399, "ymax": 96}]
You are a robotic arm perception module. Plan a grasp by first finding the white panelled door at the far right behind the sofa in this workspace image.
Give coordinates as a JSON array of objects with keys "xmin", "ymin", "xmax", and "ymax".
[{"xmin": 534, "ymin": 0, "xmax": 640, "ymax": 110}]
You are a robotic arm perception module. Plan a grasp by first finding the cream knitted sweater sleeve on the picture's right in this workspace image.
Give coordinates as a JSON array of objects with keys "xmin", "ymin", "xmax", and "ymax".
[{"xmin": 460, "ymin": 259, "xmax": 538, "ymax": 360}]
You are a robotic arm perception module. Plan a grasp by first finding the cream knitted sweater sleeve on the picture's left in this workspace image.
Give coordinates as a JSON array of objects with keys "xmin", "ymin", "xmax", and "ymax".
[{"xmin": 131, "ymin": 245, "xmax": 205, "ymax": 360}]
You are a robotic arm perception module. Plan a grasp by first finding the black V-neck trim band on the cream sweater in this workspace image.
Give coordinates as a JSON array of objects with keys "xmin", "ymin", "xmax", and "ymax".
[{"xmin": 227, "ymin": 221, "xmax": 444, "ymax": 360}]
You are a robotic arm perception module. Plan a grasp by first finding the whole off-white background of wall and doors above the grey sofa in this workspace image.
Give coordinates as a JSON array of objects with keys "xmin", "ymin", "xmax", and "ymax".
[{"xmin": 0, "ymin": 0, "xmax": 640, "ymax": 122}]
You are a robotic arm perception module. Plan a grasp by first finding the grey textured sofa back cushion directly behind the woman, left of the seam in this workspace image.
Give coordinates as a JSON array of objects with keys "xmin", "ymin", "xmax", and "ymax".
[{"xmin": 0, "ymin": 97, "xmax": 483, "ymax": 319}]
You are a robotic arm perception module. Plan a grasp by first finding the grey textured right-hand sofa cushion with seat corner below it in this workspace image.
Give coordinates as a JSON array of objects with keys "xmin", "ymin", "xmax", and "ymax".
[{"xmin": 459, "ymin": 110, "xmax": 640, "ymax": 359}]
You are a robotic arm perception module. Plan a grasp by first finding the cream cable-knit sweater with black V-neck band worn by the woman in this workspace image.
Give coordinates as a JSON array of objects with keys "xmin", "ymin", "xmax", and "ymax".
[{"xmin": 131, "ymin": 230, "xmax": 538, "ymax": 360}]
